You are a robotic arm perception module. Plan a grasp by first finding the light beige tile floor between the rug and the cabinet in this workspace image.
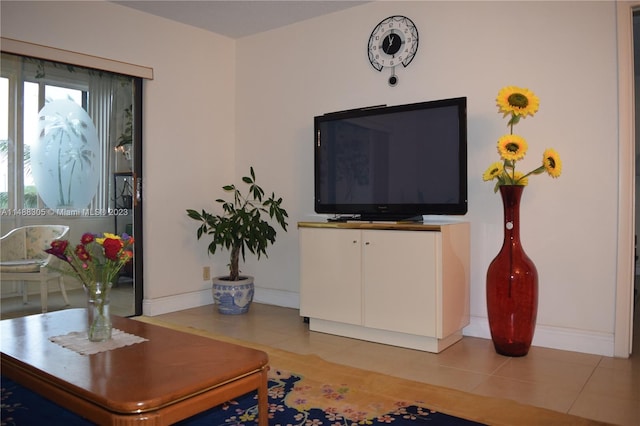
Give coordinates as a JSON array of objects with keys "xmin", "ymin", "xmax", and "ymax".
[{"xmin": 156, "ymin": 303, "xmax": 640, "ymax": 426}]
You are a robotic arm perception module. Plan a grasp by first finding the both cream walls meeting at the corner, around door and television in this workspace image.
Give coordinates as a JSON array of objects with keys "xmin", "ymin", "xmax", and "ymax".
[{"xmin": 1, "ymin": 1, "xmax": 618, "ymax": 354}]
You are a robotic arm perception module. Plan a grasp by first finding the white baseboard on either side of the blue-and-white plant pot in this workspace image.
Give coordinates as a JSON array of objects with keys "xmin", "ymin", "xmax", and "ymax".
[{"xmin": 142, "ymin": 286, "xmax": 300, "ymax": 317}]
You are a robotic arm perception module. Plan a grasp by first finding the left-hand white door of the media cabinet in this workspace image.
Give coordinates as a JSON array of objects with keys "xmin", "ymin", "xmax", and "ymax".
[{"xmin": 300, "ymin": 228, "xmax": 362, "ymax": 325}]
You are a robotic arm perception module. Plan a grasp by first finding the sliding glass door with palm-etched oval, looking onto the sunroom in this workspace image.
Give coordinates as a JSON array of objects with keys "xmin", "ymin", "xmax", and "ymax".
[{"xmin": 0, "ymin": 53, "xmax": 143, "ymax": 316}]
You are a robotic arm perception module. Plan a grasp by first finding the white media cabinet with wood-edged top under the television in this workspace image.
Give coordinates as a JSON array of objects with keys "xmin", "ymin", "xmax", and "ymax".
[{"xmin": 298, "ymin": 222, "xmax": 470, "ymax": 352}]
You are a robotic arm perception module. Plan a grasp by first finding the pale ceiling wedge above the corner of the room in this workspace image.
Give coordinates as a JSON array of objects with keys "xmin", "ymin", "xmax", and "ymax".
[{"xmin": 114, "ymin": 0, "xmax": 367, "ymax": 38}]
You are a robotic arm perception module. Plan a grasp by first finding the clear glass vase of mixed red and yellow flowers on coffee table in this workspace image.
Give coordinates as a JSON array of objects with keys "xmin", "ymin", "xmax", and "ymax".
[{"xmin": 45, "ymin": 232, "xmax": 133, "ymax": 342}]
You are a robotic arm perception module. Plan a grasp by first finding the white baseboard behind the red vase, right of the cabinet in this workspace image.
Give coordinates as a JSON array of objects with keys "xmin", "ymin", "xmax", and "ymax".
[{"xmin": 462, "ymin": 317, "xmax": 614, "ymax": 357}]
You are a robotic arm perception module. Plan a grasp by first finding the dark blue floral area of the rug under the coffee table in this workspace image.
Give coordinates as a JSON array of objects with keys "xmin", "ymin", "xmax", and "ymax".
[{"xmin": 1, "ymin": 370, "xmax": 481, "ymax": 426}]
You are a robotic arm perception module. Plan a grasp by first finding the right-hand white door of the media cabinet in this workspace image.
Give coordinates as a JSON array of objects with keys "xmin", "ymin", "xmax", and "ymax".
[{"xmin": 362, "ymin": 230, "xmax": 440, "ymax": 336}]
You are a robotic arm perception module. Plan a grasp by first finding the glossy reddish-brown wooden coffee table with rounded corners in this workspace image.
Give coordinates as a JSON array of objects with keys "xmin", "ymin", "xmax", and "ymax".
[{"xmin": 0, "ymin": 309, "xmax": 268, "ymax": 426}]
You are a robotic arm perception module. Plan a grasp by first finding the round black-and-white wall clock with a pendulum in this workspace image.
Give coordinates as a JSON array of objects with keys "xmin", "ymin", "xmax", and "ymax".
[{"xmin": 367, "ymin": 15, "xmax": 418, "ymax": 86}]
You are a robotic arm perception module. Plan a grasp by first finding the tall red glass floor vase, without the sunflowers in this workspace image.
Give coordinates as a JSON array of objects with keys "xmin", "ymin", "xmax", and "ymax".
[{"xmin": 486, "ymin": 185, "xmax": 538, "ymax": 357}]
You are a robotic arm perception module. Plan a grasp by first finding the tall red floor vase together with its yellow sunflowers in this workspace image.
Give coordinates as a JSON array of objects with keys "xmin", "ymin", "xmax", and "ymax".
[{"xmin": 483, "ymin": 86, "xmax": 562, "ymax": 356}]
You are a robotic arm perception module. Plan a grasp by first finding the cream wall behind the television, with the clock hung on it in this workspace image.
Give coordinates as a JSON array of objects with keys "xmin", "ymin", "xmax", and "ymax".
[{"xmin": 236, "ymin": 2, "xmax": 618, "ymax": 354}]
